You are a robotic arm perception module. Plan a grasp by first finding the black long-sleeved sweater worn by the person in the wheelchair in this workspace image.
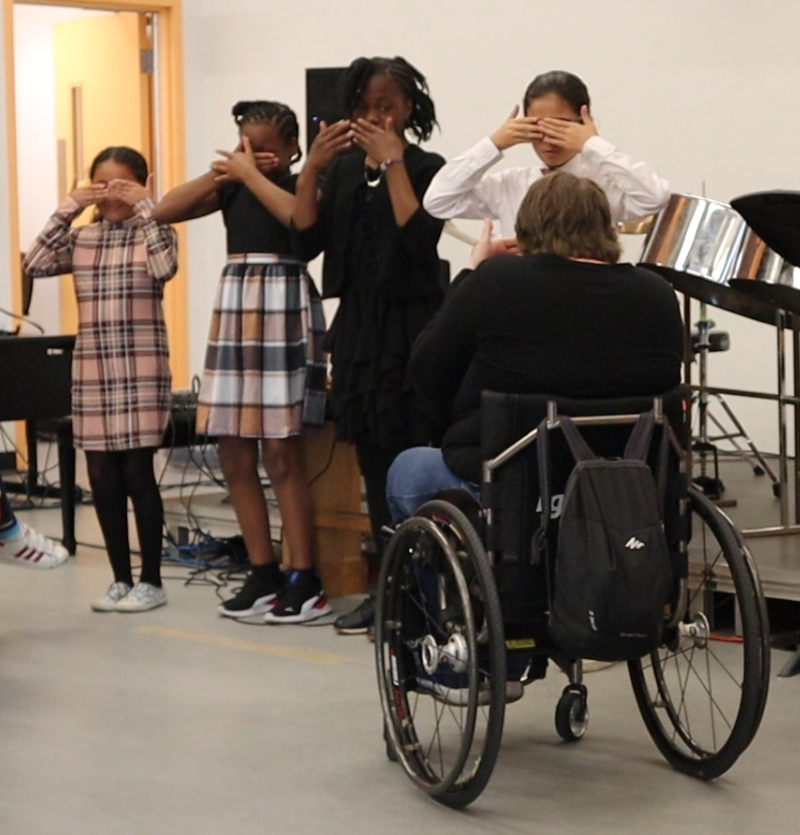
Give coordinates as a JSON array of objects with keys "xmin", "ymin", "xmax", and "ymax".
[{"xmin": 410, "ymin": 255, "xmax": 683, "ymax": 482}]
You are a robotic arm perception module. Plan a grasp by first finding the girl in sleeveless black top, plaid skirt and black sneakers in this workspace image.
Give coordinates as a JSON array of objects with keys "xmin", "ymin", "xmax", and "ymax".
[{"xmin": 156, "ymin": 101, "xmax": 330, "ymax": 623}]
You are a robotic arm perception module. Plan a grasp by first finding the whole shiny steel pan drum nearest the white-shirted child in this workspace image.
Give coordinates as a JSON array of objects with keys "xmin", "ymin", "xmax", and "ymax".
[{"xmin": 640, "ymin": 194, "xmax": 775, "ymax": 324}]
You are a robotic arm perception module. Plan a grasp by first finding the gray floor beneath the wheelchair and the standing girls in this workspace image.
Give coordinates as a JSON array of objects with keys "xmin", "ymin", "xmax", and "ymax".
[{"xmin": 0, "ymin": 494, "xmax": 800, "ymax": 835}]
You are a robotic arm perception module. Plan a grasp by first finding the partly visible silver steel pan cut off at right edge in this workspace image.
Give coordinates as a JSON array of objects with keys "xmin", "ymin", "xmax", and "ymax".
[{"xmin": 730, "ymin": 229, "xmax": 800, "ymax": 313}]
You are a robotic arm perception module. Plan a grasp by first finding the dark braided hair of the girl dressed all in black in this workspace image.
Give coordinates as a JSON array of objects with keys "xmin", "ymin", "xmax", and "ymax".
[{"xmin": 343, "ymin": 57, "xmax": 438, "ymax": 142}]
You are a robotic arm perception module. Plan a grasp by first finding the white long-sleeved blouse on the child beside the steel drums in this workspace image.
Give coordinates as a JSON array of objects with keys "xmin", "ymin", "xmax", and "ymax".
[{"xmin": 423, "ymin": 136, "xmax": 670, "ymax": 236}]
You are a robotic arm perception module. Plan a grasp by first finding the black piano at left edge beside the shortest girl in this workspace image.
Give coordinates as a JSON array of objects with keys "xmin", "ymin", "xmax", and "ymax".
[{"xmin": 0, "ymin": 335, "xmax": 75, "ymax": 554}]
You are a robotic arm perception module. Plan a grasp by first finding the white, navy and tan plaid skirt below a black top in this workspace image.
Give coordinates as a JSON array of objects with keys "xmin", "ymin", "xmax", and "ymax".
[{"xmin": 197, "ymin": 253, "xmax": 327, "ymax": 438}]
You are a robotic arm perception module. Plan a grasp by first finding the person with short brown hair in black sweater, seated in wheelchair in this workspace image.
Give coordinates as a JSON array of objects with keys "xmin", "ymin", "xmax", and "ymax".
[{"xmin": 387, "ymin": 173, "xmax": 683, "ymax": 701}]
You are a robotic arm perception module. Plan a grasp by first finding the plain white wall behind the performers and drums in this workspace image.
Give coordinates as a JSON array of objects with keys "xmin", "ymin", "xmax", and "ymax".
[{"xmin": 0, "ymin": 0, "xmax": 800, "ymax": 458}]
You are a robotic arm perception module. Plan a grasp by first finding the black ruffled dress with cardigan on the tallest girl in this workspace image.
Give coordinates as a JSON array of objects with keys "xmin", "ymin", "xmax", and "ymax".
[{"xmin": 294, "ymin": 145, "xmax": 444, "ymax": 450}]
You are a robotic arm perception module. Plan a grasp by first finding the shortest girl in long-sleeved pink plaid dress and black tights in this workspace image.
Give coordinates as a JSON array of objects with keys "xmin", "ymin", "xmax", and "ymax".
[{"xmin": 24, "ymin": 147, "xmax": 178, "ymax": 612}]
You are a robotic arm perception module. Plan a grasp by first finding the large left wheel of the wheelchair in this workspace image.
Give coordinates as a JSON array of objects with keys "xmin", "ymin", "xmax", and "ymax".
[{"xmin": 375, "ymin": 501, "xmax": 506, "ymax": 808}]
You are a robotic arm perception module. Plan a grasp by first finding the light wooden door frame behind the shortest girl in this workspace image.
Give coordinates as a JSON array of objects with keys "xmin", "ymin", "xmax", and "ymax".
[{"xmin": 2, "ymin": 0, "xmax": 189, "ymax": 388}]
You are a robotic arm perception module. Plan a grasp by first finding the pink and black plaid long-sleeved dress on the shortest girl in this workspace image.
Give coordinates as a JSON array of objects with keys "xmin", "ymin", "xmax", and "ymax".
[{"xmin": 23, "ymin": 197, "xmax": 178, "ymax": 451}]
